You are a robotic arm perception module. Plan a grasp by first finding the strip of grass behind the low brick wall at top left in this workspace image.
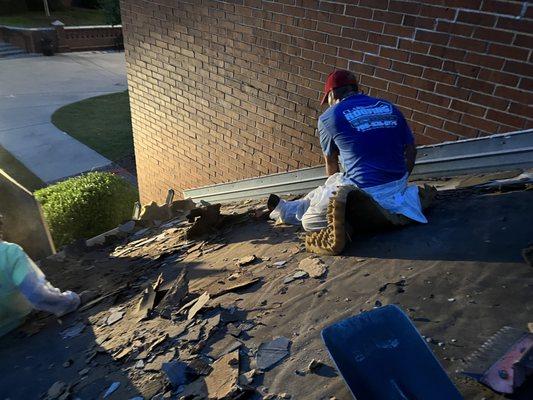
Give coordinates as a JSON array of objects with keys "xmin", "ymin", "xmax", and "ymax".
[{"xmin": 0, "ymin": 7, "xmax": 106, "ymax": 28}]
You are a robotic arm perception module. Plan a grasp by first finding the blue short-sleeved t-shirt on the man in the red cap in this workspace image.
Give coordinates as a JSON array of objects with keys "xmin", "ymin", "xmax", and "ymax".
[{"xmin": 318, "ymin": 94, "xmax": 414, "ymax": 188}]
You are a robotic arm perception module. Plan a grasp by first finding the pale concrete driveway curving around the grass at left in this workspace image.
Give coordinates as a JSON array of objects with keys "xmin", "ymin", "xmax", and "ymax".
[{"xmin": 0, "ymin": 52, "xmax": 127, "ymax": 182}]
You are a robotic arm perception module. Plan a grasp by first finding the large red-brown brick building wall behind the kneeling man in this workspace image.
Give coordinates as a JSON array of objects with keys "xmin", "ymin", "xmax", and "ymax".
[{"xmin": 122, "ymin": 0, "xmax": 533, "ymax": 201}]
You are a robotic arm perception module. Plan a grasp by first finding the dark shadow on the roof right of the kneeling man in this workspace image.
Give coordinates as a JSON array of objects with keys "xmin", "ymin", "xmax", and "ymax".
[{"xmin": 343, "ymin": 191, "xmax": 533, "ymax": 262}]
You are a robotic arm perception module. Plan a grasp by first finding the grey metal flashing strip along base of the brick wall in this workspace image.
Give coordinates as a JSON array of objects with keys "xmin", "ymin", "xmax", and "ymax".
[{"xmin": 183, "ymin": 129, "xmax": 533, "ymax": 203}]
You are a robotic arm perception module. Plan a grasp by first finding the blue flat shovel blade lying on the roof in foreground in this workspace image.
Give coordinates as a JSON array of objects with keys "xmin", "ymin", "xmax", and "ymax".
[{"xmin": 322, "ymin": 305, "xmax": 462, "ymax": 400}]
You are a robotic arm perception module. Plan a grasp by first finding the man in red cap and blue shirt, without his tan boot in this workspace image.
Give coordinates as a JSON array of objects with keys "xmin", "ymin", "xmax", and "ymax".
[{"xmin": 268, "ymin": 70, "xmax": 427, "ymax": 231}]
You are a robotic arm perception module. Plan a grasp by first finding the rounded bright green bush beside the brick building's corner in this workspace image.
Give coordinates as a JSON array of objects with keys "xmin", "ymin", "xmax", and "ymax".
[{"xmin": 35, "ymin": 172, "xmax": 138, "ymax": 246}]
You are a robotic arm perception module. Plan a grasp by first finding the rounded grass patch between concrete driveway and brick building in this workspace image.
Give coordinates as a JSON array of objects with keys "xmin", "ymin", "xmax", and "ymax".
[{"xmin": 52, "ymin": 91, "xmax": 133, "ymax": 161}]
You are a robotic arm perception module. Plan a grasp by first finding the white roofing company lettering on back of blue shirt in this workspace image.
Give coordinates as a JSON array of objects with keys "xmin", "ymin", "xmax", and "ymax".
[{"xmin": 343, "ymin": 101, "xmax": 398, "ymax": 132}]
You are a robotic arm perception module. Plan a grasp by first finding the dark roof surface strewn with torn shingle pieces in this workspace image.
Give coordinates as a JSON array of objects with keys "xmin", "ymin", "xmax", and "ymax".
[{"xmin": 0, "ymin": 172, "xmax": 533, "ymax": 400}]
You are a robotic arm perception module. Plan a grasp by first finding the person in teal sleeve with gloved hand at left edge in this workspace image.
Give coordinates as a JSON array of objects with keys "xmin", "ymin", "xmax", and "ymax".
[{"xmin": 0, "ymin": 216, "xmax": 80, "ymax": 337}]
